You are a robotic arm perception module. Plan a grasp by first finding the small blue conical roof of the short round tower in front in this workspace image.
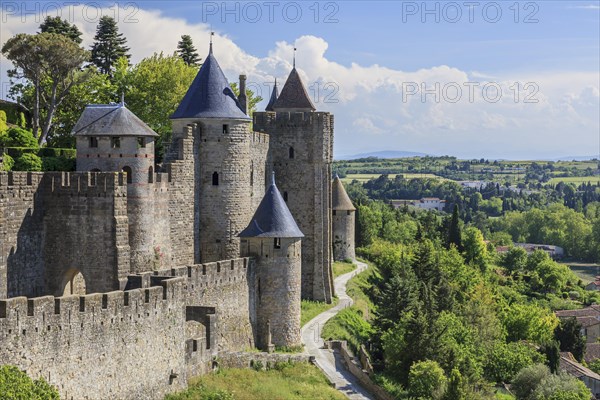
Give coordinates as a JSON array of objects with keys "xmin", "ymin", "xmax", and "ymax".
[{"xmin": 238, "ymin": 176, "xmax": 304, "ymax": 238}]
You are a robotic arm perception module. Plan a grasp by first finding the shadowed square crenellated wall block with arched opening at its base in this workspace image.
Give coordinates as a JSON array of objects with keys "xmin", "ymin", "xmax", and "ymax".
[{"xmin": 40, "ymin": 172, "xmax": 130, "ymax": 295}]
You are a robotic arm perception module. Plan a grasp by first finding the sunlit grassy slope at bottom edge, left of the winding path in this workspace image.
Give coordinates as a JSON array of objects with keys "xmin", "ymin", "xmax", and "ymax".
[{"xmin": 165, "ymin": 363, "xmax": 346, "ymax": 400}]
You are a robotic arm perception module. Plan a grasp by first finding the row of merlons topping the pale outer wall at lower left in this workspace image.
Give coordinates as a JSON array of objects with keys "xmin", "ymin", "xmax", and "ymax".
[{"xmin": 0, "ymin": 277, "xmax": 185, "ymax": 324}]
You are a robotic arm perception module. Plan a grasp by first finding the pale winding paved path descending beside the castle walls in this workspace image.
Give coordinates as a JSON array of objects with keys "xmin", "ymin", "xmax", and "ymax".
[{"xmin": 302, "ymin": 261, "xmax": 373, "ymax": 400}]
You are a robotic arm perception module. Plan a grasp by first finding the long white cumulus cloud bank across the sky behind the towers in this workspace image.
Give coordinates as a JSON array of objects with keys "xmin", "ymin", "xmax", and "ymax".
[{"xmin": 0, "ymin": 3, "xmax": 600, "ymax": 158}]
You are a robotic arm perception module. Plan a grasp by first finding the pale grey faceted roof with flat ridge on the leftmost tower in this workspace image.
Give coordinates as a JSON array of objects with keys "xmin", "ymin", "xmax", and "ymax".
[{"xmin": 71, "ymin": 103, "xmax": 158, "ymax": 136}]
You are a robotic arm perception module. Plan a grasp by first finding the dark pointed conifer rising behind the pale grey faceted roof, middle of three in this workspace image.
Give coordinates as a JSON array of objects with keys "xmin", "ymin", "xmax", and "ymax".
[{"xmin": 92, "ymin": 15, "xmax": 131, "ymax": 76}]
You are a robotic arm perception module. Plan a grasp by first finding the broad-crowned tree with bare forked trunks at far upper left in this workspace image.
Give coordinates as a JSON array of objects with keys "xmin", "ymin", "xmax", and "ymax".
[{"xmin": 2, "ymin": 33, "xmax": 89, "ymax": 144}]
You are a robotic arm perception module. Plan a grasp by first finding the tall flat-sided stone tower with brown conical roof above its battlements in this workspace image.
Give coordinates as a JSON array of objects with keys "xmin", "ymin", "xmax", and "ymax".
[{"xmin": 254, "ymin": 67, "xmax": 333, "ymax": 302}]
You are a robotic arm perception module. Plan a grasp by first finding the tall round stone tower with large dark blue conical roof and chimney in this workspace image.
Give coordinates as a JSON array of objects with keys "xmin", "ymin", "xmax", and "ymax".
[{"xmin": 171, "ymin": 43, "xmax": 258, "ymax": 262}]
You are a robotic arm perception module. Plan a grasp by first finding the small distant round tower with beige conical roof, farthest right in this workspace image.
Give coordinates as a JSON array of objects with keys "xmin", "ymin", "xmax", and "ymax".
[{"xmin": 331, "ymin": 175, "xmax": 356, "ymax": 261}]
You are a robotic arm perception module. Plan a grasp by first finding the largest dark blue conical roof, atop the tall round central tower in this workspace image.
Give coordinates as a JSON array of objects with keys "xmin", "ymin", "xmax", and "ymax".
[{"xmin": 171, "ymin": 44, "xmax": 250, "ymax": 119}]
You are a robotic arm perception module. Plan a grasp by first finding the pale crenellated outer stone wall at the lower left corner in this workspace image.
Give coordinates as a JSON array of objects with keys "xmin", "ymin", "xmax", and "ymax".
[{"xmin": 0, "ymin": 278, "xmax": 187, "ymax": 400}]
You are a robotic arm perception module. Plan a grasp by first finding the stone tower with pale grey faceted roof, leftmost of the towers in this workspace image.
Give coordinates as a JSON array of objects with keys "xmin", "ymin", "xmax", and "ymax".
[{"xmin": 73, "ymin": 102, "xmax": 171, "ymax": 273}]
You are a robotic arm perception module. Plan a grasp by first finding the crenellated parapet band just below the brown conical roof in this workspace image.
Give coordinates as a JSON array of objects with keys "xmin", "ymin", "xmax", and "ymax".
[{"xmin": 253, "ymin": 111, "xmax": 333, "ymax": 132}]
